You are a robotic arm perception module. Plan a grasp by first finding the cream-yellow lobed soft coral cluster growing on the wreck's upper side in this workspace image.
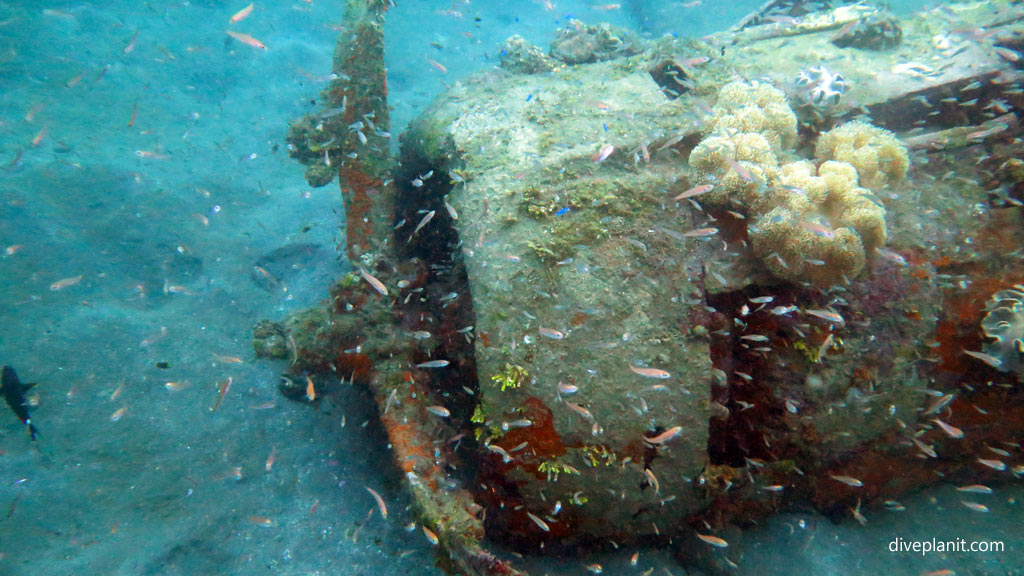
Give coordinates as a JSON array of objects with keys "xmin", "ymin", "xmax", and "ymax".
[{"xmin": 690, "ymin": 82, "xmax": 908, "ymax": 286}]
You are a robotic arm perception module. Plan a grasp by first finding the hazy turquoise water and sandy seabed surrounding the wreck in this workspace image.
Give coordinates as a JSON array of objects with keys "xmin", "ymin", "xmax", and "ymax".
[{"xmin": 0, "ymin": 0, "xmax": 1024, "ymax": 575}]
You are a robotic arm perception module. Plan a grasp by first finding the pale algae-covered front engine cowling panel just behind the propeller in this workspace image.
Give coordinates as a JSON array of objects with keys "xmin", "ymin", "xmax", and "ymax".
[{"xmin": 404, "ymin": 42, "xmax": 720, "ymax": 542}]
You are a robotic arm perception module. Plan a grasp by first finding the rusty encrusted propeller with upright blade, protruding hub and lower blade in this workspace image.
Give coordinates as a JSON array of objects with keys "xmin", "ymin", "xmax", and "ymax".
[{"xmin": 270, "ymin": 0, "xmax": 519, "ymax": 576}]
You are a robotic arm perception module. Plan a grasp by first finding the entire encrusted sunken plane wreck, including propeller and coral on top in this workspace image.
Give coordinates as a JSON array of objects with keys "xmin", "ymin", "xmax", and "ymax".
[{"xmin": 254, "ymin": 0, "xmax": 1024, "ymax": 574}]
